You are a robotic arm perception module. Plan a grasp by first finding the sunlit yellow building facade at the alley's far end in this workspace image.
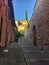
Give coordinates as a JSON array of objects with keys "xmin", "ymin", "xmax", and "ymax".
[{"xmin": 15, "ymin": 20, "xmax": 28, "ymax": 32}]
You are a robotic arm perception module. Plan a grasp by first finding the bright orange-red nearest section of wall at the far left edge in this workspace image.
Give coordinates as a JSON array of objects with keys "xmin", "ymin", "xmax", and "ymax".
[{"xmin": 0, "ymin": 0, "xmax": 6, "ymax": 46}]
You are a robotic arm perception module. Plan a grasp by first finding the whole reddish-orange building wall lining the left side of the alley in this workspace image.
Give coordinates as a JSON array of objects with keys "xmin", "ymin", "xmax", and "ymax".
[{"xmin": 0, "ymin": 0, "xmax": 14, "ymax": 47}]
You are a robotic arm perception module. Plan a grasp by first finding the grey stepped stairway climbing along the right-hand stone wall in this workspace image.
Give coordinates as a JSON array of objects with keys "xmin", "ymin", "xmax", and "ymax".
[{"xmin": 19, "ymin": 38, "xmax": 49, "ymax": 65}]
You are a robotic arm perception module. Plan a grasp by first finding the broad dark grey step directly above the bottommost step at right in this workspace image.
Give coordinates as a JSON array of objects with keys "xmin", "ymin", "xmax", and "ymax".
[{"xmin": 24, "ymin": 52, "xmax": 49, "ymax": 60}]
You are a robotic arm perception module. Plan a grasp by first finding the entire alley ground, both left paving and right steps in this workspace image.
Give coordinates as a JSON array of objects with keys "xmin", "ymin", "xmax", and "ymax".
[{"xmin": 0, "ymin": 38, "xmax": 49, "ymax": 65}]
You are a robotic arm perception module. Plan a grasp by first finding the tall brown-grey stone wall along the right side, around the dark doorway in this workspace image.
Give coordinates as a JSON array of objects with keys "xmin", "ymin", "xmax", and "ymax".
[{"xmin": 28, "ymin": 0, "xmax": 49, "ymax": 49}]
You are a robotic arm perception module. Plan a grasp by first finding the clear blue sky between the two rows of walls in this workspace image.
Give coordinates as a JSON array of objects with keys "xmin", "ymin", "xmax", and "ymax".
[{"xmin": 13, "ymin": 0, "xmax": 36, "ymax": 20}]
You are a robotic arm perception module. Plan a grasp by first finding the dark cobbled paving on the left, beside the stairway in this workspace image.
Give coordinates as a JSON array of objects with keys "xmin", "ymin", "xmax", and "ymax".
[{"xmin": 0, "ymin": 43, "xmax": 26, "ymax": 65}]
